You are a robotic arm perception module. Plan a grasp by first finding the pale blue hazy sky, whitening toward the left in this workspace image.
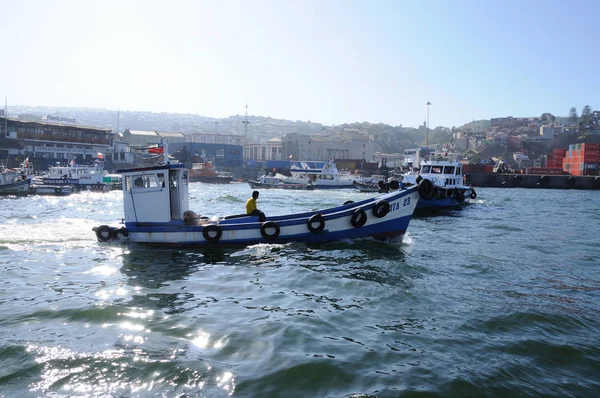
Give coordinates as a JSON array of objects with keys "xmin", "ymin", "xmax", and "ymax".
[{"xmin": 0, "ymin": 0, "xmax": 600, "ymax": 128}]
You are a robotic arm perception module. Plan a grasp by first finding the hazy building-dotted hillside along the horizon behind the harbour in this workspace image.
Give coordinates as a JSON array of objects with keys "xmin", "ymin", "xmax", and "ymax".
[{"xmin": 8, "ymin": 106, "xmax": 600, "ymax": 173}]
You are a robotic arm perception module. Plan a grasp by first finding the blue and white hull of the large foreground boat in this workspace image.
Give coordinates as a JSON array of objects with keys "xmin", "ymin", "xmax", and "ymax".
[{"xmin": 117, "ymin": 187, "xmax": 419, "ymax": 247}]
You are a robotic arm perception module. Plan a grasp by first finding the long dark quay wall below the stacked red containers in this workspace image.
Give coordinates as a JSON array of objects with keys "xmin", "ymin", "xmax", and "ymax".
[{"xmin": 465, "ymin": 173, "xmax": 600, "ymax": 190}]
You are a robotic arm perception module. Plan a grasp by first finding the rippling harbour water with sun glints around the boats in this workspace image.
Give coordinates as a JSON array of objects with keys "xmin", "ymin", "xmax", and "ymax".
[{"xmin": 0, "ymin": 183, "xmax": 600, "ymax": 397}]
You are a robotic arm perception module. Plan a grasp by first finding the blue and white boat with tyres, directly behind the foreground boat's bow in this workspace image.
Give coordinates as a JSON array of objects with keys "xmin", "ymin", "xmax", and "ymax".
[{"xmin": 401, "ymin": 160, "xmax": 477, "ymax": 209}]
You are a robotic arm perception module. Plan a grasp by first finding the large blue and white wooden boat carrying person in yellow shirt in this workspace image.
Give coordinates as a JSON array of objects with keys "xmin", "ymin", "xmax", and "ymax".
[{"xmin": 93, "ymin": 144, "xmax": 419, "ymax": 247}]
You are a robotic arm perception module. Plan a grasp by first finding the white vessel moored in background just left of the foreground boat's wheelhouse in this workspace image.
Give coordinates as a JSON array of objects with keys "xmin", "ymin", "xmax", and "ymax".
[{"xmin": 41, "ymin": 154, "xmax": 110, "ymax": 191}]
